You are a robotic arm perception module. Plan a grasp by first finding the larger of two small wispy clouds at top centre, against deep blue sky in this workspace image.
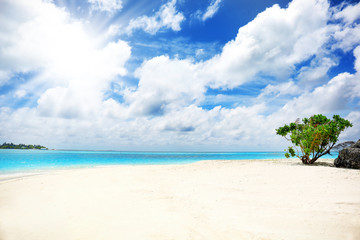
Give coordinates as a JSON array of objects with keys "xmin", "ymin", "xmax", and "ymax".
[{"xmin": 126, "ymin": 0, "xmax": 185, "ymax": 35}]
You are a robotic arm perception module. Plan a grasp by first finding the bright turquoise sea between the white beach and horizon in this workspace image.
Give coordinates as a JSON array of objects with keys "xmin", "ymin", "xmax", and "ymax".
[{"xmin": 0, "ymin": 149, "xmax": 336, "ymax": 173}]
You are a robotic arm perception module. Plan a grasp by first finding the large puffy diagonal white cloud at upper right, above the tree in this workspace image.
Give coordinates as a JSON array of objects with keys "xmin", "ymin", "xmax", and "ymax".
[{"xmin": 198, "ymin": 0, "xmax": 329, "ymax": 88}]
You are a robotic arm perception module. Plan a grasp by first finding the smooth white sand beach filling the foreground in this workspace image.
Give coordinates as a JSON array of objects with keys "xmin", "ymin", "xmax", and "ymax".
[{"xmin": 0, "ymin": 160, "xmax": 360, "ymax": 240}]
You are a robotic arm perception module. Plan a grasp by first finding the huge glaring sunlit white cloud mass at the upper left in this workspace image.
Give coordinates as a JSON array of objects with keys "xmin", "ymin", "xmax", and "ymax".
[{"xmin": 0, "ymin": 0, "xmax": 131, "ymax": 118}]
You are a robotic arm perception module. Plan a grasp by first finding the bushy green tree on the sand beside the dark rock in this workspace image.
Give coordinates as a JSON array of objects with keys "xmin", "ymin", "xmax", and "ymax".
[{"xmin": 276, "ymin": 114, "xmax": 352, "ymax": 164}]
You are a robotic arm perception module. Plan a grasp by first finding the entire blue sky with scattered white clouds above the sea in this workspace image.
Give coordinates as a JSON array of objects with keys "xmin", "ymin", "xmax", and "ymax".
[{"xmin": 0, "ymin": 0, "xmax": 360, "ymax": 151}]
